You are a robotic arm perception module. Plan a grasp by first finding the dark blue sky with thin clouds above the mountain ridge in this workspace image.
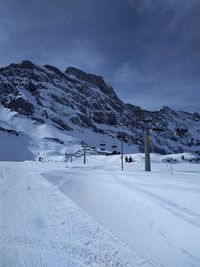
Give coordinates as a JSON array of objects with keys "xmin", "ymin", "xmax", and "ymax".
[{"xmin": 0, "ymin": 0, "xmax": 200, "ymax": 110}]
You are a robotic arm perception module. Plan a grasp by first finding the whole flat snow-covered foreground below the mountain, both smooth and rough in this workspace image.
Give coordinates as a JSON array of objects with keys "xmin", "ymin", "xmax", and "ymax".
[{"xmin": 0, "ymin": 156, "xmax": 200, "ymax": 267}]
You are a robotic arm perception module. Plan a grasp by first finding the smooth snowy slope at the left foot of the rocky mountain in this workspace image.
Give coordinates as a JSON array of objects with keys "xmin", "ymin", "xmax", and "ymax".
[{"xmin": 0, "ymin": 107, "xmax": 80, "ymax": 161}]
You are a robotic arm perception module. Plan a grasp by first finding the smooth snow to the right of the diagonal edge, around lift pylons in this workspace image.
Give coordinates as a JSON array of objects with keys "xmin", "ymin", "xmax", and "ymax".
[{"xmin": 44, "ymin": 158, "xmax": 200, "ymax": 267}]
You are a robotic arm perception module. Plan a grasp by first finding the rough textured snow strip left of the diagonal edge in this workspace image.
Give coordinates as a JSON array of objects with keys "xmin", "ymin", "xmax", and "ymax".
[{"xmin": 0, "ymin": 162, "xmax": 152, "ymax": 267}]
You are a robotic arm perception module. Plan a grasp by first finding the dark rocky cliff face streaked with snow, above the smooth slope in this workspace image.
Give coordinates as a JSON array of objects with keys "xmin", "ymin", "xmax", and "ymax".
[{"xmin": 0, "ymin": 61, "xmax": 200, "ymax": 153}]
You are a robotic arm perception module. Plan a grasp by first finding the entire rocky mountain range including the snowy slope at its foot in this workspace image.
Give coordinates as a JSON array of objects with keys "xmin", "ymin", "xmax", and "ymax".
[{"xmin": 0, "ymin": 61, "xmax": 200, "ymax": 160}]
